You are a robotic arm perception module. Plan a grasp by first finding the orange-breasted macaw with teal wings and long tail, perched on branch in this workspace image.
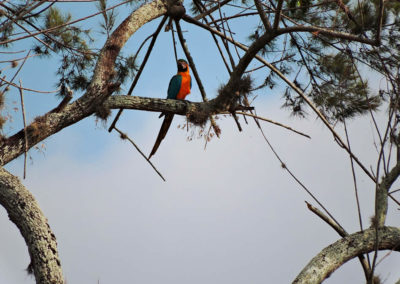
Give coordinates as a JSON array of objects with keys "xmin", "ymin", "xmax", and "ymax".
[{"xmin": 149, "ymin": 59, "xmax": 192, "ymax": 159}]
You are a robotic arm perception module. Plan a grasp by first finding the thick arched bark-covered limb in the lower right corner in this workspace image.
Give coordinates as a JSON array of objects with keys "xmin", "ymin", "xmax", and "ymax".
[{"xmin": 293, "ymin": 227, "xmax": 400, "ymax": 284}]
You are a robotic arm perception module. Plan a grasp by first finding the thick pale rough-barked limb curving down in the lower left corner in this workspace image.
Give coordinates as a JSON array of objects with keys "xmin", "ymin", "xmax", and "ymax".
[{"xmin": 0, "ymin": 168, "xmax": 64, "ymax": 284}]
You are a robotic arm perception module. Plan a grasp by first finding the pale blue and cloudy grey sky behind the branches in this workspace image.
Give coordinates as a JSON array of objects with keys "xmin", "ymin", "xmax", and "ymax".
[{"xmin": 0, "ymin": 1, "xmax": 400, "ymax": 284}]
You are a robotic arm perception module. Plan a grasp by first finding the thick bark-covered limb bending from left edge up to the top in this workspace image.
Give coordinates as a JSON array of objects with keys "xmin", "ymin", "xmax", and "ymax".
[{"xmin": 0, "ymin": 0, "xmax": 167, "ymax": 166}]
